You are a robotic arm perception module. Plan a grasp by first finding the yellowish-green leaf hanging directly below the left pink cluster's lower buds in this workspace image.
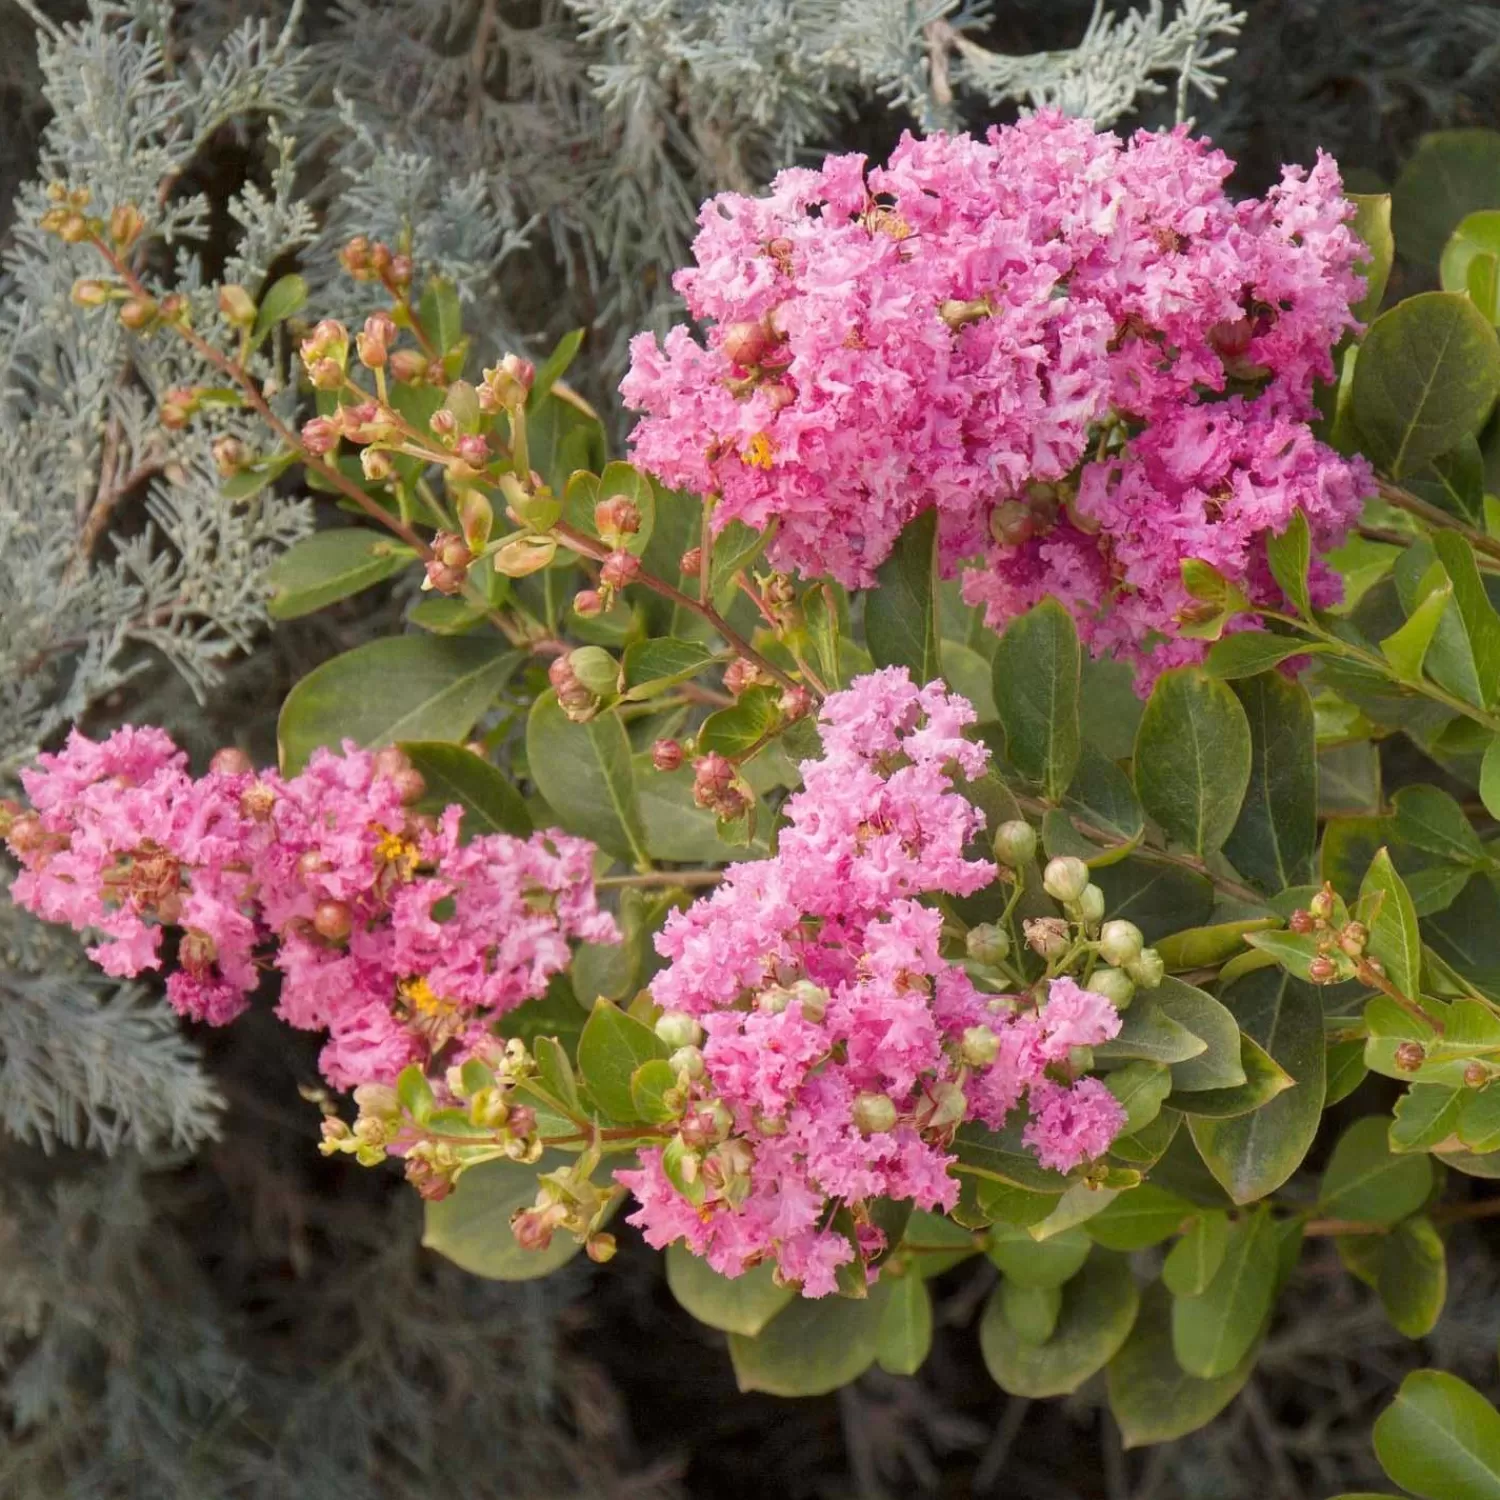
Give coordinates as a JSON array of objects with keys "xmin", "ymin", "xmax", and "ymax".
[{"xmin": 422, "ymin": 1151, "xmax": 582, "ymax": 1281}]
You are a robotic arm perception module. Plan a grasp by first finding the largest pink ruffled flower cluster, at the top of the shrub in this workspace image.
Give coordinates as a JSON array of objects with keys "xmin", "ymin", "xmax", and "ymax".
[{"xmin": 621, "ymin": 111, "xmax": 1368, "ymax": 687}]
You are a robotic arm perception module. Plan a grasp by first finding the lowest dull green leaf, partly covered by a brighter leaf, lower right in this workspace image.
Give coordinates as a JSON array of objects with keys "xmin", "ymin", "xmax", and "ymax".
[{"xmin": 1107, "ymin": 1286, "xmax": 1256, "ymax": 1448}]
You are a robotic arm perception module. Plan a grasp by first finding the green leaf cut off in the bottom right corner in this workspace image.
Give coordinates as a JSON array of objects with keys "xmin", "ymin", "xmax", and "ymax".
[{"xmin": 1376, "ymin": 1370, "xmax": 1500, "ymax": 1500}]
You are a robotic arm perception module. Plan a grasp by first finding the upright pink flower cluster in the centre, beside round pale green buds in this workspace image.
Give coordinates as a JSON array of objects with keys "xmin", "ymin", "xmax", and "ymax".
[{"xmin": 618, "ymin": 668, "xmax": 1124, "ymax": 1296}]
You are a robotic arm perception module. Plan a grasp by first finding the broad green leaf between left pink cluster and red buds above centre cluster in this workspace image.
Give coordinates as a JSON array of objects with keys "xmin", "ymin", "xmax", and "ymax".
[{"xmin": 527, "ymin": 689, "xmax": 647, "ymax": 863}]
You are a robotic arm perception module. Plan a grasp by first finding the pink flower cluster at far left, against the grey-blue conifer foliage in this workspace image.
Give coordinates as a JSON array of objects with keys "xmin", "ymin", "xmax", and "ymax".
[{"xmin": 6, "ymin": 728, "xmax": 618, "ymax": 1088}]
